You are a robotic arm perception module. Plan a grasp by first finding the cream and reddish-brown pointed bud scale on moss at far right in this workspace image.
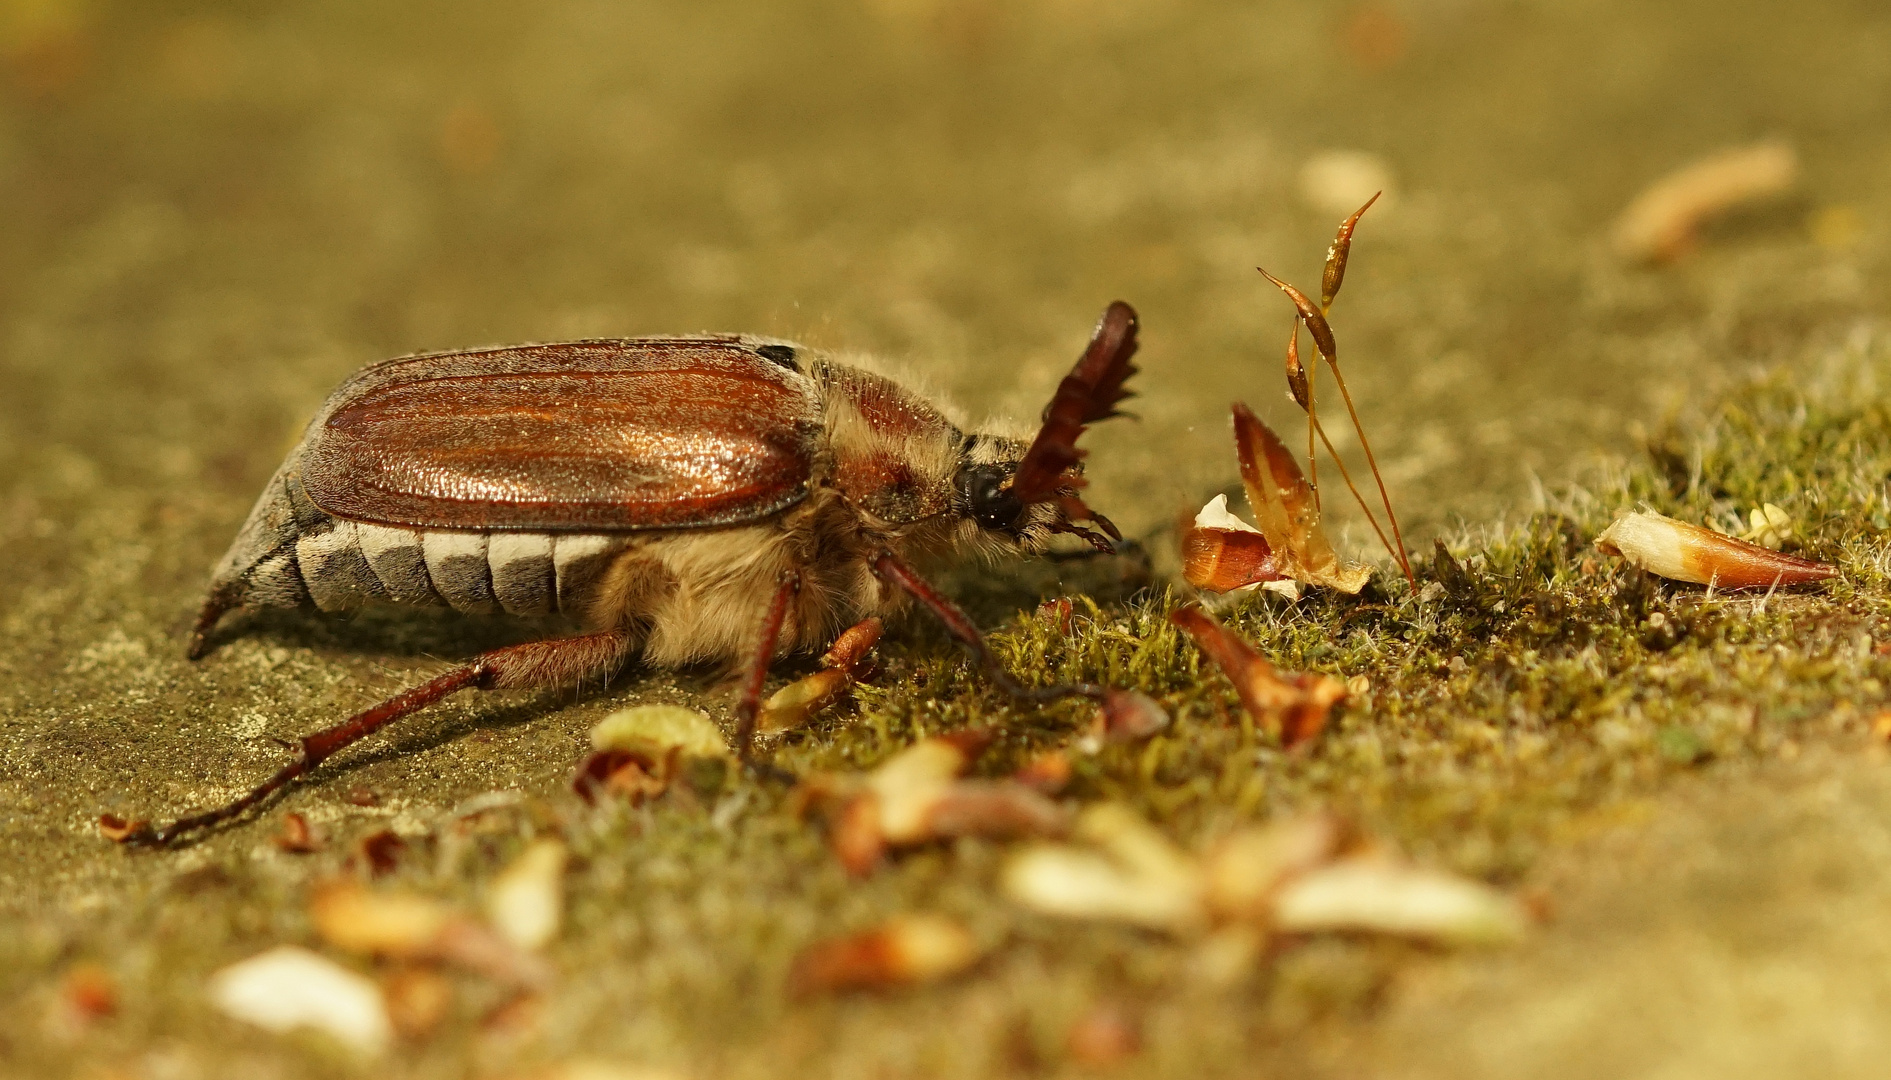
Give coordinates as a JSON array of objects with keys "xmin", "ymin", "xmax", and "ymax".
[{"xmin": 1596, "ymin": 511, "xmax": 1838, "ymax": 588}]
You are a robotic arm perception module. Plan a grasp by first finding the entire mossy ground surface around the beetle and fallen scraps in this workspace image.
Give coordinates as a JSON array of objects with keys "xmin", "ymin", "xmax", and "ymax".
[{"xmin": 0, "ymin": 0, "xmax": 1891, "ymax": 1080}]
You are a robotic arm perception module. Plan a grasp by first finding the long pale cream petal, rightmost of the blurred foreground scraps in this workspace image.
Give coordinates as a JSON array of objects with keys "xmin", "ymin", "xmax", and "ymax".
[{"xmin": 1275, "ymin": 857, "xmax": 1530, "ymax": 944}]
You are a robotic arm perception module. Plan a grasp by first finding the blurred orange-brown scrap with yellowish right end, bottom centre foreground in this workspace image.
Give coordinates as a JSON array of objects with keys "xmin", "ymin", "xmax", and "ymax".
[{"xmin": 789, "ymin": 914, "xmax": 980, "ymax": 997}]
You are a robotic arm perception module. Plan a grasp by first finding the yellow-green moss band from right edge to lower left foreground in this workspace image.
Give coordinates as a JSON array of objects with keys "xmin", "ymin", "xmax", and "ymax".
[{"xmin": 14, "ymin": 325, "xmax": 1891, "ymax": 1076}]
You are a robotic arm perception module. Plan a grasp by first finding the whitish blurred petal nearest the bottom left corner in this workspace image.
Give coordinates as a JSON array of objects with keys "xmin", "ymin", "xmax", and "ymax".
[{"xmin": 208, "ymin": 946, "xmax": 393, "ymax": 1055}]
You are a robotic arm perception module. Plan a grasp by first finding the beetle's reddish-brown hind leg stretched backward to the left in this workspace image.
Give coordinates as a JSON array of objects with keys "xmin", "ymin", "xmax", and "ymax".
[{"xmin": 125, "ymin": 630, "xmax": 630, "ymax": 845}]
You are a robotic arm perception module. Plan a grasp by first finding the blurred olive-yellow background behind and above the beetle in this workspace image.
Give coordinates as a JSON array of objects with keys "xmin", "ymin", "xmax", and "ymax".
[{"xmin": 0, "ymin": 0, "xmax": 1891, "ymax": 571}]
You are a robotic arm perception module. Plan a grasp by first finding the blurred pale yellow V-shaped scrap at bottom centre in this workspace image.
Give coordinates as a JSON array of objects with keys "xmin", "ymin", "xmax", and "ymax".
[{"xmin": 1000, "ymin": 804, "xmax": 1203, "ymax": 931}]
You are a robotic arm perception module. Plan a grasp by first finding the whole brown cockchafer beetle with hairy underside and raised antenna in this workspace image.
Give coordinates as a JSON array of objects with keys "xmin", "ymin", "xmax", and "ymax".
[{"xmin": 117, "ymin": 301, "xmax": 1159, "ymax": 844}]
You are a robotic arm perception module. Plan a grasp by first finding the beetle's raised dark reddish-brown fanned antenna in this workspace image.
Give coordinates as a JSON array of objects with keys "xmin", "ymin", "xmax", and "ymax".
[{"xmin": 1012, "ymin": 301, "xmax": 1136, "ymax": 518}]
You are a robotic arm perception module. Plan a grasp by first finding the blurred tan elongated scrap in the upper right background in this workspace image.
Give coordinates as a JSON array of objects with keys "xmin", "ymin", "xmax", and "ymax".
[{"xmin": 1611, "ymin": 140, "xmax": 1798, "ymax": 263}]
